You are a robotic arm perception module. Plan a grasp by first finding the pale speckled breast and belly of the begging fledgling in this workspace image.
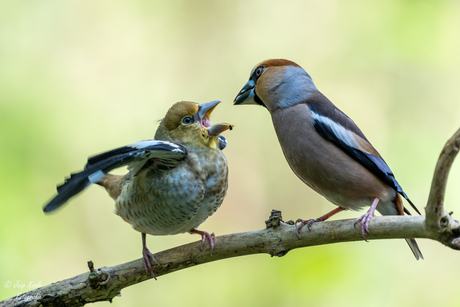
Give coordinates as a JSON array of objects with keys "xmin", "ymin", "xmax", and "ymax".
[{"xmin": 115, "ymin": 150, "xmax": 228, "ymax": 235}]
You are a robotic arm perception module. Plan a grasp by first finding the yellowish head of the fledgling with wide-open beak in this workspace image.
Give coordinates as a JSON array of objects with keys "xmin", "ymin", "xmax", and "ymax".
[{"xmin": 155, "ymin": 100, "xmax": 233, "ymax": 148}]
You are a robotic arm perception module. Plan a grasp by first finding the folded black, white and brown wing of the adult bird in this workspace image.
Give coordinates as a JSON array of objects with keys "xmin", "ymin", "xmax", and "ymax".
[{"xmin": 307, "ymin": 94, "xmax": 420, "ymax": 214}]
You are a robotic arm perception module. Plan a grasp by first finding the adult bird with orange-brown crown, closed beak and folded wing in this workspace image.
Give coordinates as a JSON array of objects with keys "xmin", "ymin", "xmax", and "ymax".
[{"xmin": 233, "ymin": 59, "xmax": 423, "ymax": 260}]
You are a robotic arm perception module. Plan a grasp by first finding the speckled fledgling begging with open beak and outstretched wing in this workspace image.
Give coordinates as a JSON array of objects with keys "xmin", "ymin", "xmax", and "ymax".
[{"xmin": 43, "ymin": 100, "xmax": 233, "ymax": 279}]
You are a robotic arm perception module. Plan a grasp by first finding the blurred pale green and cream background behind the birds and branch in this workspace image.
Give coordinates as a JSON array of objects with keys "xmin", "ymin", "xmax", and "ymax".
[{"xmin": 0, "ymin": 0, "xmax": 460, "ymax": 307}]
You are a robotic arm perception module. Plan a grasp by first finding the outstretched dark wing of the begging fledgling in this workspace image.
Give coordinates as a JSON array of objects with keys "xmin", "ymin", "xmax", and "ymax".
[{"xmin": 43, "ymin": 140, "xmax": 187, "ymax": 212}]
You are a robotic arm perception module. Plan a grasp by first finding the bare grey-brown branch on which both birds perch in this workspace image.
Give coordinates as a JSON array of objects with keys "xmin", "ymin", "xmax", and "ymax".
[{"xmin": 0, "ymin": 129, "xmax": 460, "ymax": 307}]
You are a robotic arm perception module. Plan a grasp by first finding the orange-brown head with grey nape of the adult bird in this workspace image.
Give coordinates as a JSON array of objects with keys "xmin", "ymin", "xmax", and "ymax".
[{"xmin": 233, "ymin": 59, "xmax": 318, "ymax": 112}]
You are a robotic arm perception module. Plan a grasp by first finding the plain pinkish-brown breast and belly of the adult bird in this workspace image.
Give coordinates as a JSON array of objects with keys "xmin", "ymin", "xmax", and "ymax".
[{"xmin": 272, "ymin": 104, "xmax": 396, "ymax": 210}]
